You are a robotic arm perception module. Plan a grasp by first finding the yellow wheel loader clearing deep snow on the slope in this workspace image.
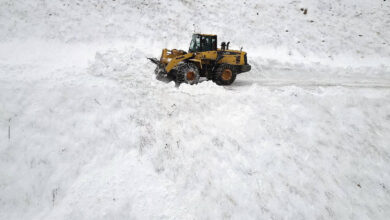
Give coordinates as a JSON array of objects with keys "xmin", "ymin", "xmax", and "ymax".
[{"xmin": 148, "ymin": 34, "xmax": 251, "ymax": 85}]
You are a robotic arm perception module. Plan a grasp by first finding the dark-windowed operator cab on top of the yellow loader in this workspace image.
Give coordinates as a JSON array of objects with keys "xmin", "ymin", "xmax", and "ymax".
[{"xmin": 188, "ymin": 34, "xmax": 217, "ymax": 53}]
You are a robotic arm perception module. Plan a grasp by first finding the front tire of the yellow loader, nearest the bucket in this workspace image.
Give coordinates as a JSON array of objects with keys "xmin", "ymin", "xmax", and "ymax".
[{"xmin": 175, "ymin": 63, "xmax": 200, "ymax": 85}]
